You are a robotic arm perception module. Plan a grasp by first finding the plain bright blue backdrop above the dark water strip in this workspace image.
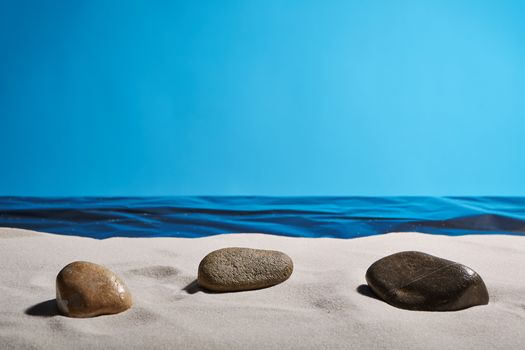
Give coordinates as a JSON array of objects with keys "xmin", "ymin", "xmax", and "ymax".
[{"xmin": 0, "ymin": 0, "xmax": 525, "ymax": 196}]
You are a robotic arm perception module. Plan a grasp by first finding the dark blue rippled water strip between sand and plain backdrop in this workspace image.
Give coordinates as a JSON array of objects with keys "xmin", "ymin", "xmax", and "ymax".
[{"xmin": 0, "ymin": 197, "xmax": 525, "ymax": 238}]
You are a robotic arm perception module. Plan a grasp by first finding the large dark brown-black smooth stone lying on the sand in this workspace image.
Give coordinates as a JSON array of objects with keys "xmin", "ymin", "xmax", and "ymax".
[{"xmin": 366, "ymin": 251, "xmax": 489, "ymax": 311}]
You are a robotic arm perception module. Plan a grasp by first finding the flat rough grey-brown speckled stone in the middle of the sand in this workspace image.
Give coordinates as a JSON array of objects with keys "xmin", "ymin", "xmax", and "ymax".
[{"xmin": 197, "ymin": 247, "xmax": 293, "ymax": 292}]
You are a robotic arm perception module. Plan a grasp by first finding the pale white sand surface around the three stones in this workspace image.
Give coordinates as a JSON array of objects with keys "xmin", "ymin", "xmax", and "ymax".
[{"xmin": 0, "ymin": 229, "xmax": 525, "ymax": 350}]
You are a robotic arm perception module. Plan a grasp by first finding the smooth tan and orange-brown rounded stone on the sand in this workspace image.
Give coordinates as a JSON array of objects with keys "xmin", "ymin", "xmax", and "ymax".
[{"xmin": 56, "ymin": 261, "xmax": 133, "ymax": 317}]
